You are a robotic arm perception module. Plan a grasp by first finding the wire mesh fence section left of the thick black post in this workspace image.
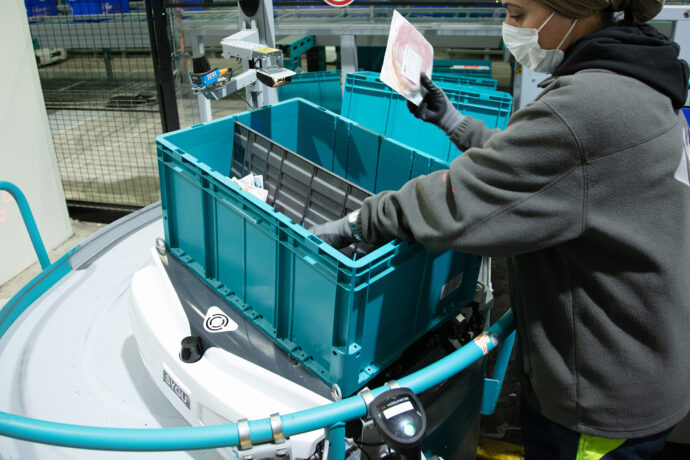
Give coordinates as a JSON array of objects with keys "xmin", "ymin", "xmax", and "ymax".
[{"xmin": 27, "ymin": 0, "xmax": 162, "ymax": 209}]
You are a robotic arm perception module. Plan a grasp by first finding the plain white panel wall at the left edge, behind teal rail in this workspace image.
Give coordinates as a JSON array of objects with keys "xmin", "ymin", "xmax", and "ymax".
[{"xmin": 0, "ymin": 0, "xmax": 72, "ymax": 284}]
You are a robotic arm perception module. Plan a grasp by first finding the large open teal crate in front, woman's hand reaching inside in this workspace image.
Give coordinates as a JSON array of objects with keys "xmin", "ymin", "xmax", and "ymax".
[{"xmin": 157, "ymin": 99, "xmax": 480, "ymax": 395}]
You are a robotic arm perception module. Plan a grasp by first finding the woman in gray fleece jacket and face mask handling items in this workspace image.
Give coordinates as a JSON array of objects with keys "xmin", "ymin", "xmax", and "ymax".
[{"xmin": 313, "ymin": 0, "xmax": 690, "ymax": 459}]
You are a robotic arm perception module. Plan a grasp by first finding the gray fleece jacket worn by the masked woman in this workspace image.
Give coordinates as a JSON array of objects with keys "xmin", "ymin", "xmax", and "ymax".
[{"xmin": 360, "ymin": 66, "xmax": 690, "ymax": 438}]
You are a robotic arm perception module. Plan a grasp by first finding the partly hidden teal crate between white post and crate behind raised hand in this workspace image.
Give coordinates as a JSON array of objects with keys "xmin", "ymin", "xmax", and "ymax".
[{"xmin": 278, "ymin": 70, "xmax": 343, "ymax": 113}]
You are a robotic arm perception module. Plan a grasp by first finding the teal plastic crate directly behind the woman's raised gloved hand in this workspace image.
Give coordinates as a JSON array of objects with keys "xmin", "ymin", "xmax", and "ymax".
[{"xmin": 340, "ymin": 72, "xmax": 513, "ymax": 163}]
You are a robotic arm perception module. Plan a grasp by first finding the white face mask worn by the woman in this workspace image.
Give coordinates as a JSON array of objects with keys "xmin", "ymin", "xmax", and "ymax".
[{"xmin": 503, "ymin": 12, "xmax": 577, "ymax": 73}]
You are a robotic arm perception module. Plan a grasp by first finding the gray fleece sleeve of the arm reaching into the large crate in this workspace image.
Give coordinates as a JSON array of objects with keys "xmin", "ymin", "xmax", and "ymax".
[{"xmin": 360, "ymin": 102, "xmax": 586, "ymax": 256}]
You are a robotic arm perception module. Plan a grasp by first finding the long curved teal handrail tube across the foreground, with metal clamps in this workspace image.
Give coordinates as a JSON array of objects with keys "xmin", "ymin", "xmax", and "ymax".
[{"xmin": 0, "ymin": 311, "xmax": 515, "ymax": 451}]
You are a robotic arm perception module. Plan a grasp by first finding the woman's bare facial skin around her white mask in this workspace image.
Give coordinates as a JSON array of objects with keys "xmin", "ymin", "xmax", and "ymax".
[{"xmin": 502, "ymin": 0, "xmax": 577, "ymax": 50}]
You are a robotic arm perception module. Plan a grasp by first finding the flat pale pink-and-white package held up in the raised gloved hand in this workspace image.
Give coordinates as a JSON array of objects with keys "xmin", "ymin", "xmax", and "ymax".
[{"xmin": 381, "ymin": 11, "xmax": 434, "ymax": 105}]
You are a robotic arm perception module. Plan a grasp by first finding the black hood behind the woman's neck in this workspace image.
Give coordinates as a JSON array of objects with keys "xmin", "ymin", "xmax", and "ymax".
[{"xmin": 553, "ymin": 24, "xmax": 688, "ymax": 110}]
